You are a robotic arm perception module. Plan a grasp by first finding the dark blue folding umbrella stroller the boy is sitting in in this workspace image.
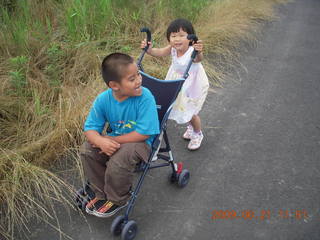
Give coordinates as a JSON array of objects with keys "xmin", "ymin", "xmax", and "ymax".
[{"xmin": 76, "ymin": 28, "xmax": 197, "ymax": 240}]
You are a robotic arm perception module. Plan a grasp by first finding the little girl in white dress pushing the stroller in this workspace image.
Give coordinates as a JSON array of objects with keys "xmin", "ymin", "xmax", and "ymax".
[{"xmin": 141, "ymin": 19, "xmax": 209, "ymax": 150}]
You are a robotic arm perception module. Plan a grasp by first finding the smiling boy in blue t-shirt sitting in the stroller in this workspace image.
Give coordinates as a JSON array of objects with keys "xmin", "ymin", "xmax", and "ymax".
[{"xmin": 80, "ymin": 53, "xmax": 159, "ymax": 217}]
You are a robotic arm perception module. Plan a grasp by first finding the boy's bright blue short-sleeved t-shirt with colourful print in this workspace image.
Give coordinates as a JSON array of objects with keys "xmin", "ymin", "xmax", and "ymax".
[{"xmin": 84, "ymin": 87, "xmax": 159, "ymax": 145}]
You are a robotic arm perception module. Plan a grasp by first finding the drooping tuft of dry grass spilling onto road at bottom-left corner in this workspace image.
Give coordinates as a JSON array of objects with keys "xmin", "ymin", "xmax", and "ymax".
[{"xmin": 0, "ymin": 152, "xmax": 76, "ymax": 238}]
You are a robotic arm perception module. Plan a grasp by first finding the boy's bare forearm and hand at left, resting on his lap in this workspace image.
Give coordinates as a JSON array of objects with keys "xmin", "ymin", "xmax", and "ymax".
[{"xmin": 84, "ymin": 130, "xmax": 120, "ymax": 156}]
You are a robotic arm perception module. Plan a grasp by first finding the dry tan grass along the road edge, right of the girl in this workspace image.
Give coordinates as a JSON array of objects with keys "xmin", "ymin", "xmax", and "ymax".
[{"xmin": 196, "ymin": 0, "xmax": 288, "ymax": 86}]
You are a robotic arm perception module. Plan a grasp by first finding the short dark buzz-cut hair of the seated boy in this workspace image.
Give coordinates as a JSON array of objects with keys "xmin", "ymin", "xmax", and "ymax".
[{"xmin": 101, "ymin": 53, "xmax": 134, "ymax": 86}]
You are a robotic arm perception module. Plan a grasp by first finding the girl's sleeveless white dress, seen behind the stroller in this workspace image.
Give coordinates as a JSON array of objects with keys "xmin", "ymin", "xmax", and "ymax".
[{"xmin": 166, "ymin": 46, "xmax": 209, "ymax": 124}]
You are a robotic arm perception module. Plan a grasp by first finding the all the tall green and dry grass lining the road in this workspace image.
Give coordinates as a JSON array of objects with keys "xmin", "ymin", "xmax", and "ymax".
[{"xmin": 0, "ymin": 0, "xmax": 285, "ymax": 239}]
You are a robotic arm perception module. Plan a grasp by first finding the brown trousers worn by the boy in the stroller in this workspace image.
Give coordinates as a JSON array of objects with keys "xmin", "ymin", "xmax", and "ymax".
[{"xmin": 80, "ymin": 142, "xmax": 151, "ymax": 205}]
